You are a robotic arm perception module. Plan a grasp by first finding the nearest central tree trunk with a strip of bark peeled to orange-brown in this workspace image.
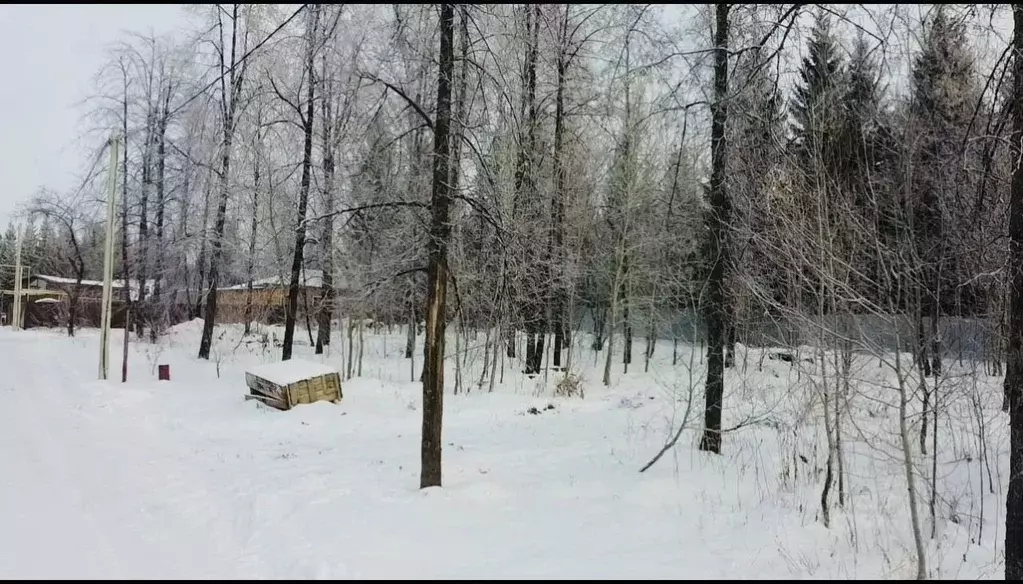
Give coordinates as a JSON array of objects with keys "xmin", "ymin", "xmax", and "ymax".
[{"xmin": 419, "ymin": 4, "xmax": 454, "ymax": 488}]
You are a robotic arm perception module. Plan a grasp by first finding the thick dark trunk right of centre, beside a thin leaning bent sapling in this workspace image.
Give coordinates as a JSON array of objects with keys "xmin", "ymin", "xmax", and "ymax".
[{"xmin": 700, "ymin": 4, "xmax": 731, "ymax": 454}]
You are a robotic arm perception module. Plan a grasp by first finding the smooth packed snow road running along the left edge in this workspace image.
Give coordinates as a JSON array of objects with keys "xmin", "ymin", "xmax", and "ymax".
[{"xmin": 0, "ymin": 333, "xmax": 251, "ymax": 578}]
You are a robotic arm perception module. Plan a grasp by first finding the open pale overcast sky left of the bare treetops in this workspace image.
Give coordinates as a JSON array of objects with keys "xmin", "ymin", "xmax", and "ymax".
[{"xmin": 0, "ymin": 4, "xmax": 187, "ymax": 229}]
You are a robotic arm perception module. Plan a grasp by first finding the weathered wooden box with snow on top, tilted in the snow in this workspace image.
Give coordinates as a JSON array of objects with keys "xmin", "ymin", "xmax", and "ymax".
[{"xmin": 246, "ymin": 359, "xmax": 342, "ymax": 410}]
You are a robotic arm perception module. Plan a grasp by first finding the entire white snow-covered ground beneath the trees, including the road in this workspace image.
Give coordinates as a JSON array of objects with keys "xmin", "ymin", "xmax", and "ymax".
[{"xmin": 0, "ymin": 321, "xmax": 1008, "ymax": 579}]
